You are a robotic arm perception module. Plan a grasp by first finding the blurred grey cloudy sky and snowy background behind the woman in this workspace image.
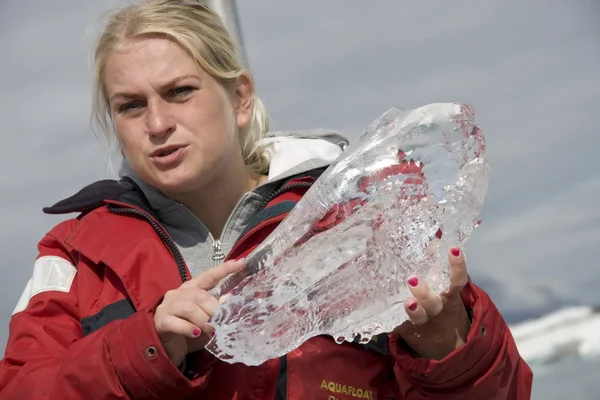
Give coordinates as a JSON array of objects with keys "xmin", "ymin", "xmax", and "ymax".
[{"xmin": 0, "ymin": 0, "xmax": 600, "ymax": 400}]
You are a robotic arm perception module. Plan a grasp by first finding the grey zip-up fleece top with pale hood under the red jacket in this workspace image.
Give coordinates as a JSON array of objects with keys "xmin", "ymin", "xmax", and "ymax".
[{"xmin": 120, "ymin": 130, "xmax": 348, "ymax": 277}]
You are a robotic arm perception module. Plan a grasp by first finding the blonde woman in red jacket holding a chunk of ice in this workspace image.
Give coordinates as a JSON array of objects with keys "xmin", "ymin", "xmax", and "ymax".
[{"xmin": 0, "ymin": 0, "xmax": 531, "ymax": 400}]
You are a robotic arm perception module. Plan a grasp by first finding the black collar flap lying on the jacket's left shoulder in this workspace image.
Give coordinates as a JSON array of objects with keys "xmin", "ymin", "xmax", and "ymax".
[{"xmin": 42, "ymin": 178, "xmax": 143, "ymax": 214}]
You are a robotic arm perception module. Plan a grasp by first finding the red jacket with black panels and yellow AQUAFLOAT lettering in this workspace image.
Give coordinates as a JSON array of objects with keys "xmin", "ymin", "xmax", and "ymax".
[{"xmin": 0, "ymin": 173, "xmax": 532, "ymax": 400}]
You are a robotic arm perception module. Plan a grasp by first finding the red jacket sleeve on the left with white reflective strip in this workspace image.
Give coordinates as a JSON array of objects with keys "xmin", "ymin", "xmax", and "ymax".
[{"xmin": 0, "ymin": 221, "xmax": 216, "ymax": 400}]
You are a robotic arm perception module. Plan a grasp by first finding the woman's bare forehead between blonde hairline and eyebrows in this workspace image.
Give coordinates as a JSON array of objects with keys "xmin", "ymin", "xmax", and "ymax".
[{"xmin": 104, "ymin": 38, "xmax": 202, "ymax": 93}]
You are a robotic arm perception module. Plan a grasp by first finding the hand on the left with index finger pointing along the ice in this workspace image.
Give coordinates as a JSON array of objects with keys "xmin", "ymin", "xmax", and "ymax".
[{"xmin": 154, "ymin": 260, "xmax": 244, "ymax": 366}]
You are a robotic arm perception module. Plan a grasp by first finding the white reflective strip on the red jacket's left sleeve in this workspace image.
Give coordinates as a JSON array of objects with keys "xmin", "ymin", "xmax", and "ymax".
[{"xmin": 13, "ymin": 256, "xmax": 77, "ymax": 315}]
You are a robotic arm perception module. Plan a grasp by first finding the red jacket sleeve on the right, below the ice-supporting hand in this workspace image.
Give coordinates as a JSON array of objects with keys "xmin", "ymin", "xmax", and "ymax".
[{"xmin": 390, "ymin": 283, "xmax": 533, "ymax": 400}]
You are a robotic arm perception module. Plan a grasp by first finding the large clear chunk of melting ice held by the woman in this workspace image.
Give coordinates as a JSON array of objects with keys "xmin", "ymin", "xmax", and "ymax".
[{"xmin": 206, "ymin": 103, "xmax": 489, "ymax": 365}]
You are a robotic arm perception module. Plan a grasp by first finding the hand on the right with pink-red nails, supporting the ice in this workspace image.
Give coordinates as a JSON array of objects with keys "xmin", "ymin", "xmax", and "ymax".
[{"xmin": 394, "ymin": 248, "xmax": 470, "ymax": 360}]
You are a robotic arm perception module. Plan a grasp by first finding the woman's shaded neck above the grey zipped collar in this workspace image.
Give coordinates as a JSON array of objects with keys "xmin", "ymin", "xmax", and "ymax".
[{"xmin": 174, "ymin": 164, "xmax": 267, "ymax": 239}]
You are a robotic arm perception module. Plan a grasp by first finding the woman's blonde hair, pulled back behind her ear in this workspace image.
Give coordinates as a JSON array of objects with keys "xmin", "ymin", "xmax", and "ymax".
[{"xmin": 92, "ymin": 0, "xmax": 269, "ymax": 174}]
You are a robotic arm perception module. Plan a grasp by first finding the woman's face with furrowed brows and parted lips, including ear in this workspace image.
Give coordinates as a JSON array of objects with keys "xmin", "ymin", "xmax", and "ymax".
[{"xmin": 105, "ymin": 38, "xmax": 252, "ymax": 194}]
